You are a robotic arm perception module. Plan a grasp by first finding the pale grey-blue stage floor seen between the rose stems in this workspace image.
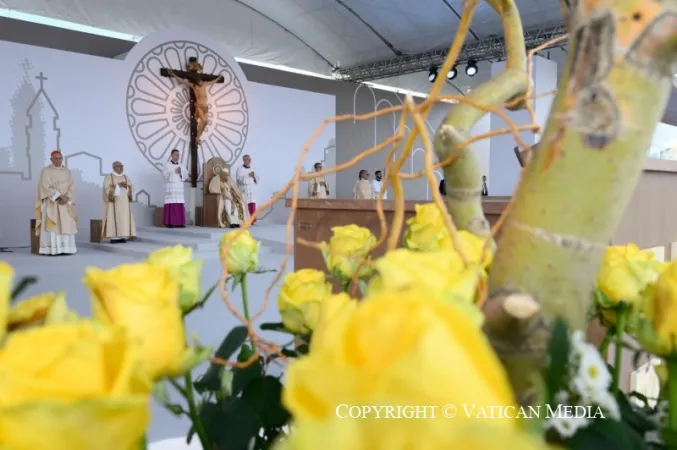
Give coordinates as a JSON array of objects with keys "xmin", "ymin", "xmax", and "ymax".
[{"xmin": 0, "ymin": 224, "xmax": 293, "ymax": 442}]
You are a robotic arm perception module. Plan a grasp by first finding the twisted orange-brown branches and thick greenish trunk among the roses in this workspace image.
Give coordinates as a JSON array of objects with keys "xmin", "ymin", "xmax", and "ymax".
[{"xmin": 214, "ymin": 0, "xmax": 677, "ymax": 403}]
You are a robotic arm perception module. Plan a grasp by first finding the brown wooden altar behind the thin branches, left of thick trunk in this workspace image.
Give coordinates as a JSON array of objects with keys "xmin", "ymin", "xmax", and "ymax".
[{"xmin": 286, "ymin": 197, "xmax": 510, "ymax": 270}]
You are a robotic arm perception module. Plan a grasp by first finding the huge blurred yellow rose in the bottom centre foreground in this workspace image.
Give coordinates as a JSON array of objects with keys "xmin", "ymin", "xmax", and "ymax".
[{"xmin": 282, "ymin": 289, "xmax": 517, "ymax": 436}]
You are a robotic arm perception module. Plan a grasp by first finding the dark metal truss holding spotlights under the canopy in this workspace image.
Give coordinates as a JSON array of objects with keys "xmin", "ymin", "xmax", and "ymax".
[{"xmin": 333, "ymin": 25, "xmax": 567, "ymax": 82}]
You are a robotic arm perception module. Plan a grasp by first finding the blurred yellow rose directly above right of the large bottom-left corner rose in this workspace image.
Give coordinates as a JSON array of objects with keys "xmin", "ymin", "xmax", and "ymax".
[{"xmin": 83, "ymin": 263, "xmax": 186, "ymax": 378}]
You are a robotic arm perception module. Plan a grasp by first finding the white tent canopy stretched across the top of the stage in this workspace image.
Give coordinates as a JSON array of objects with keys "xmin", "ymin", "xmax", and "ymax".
[{"xmin": 0, "ymin": 0, "xmax": 561, "ymax": 75}]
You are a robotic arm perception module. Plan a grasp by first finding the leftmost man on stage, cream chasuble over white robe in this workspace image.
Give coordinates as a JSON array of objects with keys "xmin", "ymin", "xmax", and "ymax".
[{"xmin": 35, "ymin": 150, "xmax": 78, "ymax": 255}]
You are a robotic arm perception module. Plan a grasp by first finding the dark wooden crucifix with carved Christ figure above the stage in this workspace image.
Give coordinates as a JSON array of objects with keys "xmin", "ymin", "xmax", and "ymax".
[{"xmin": 160, "ymin": 57, "xmax": 224, "ymax": 223}]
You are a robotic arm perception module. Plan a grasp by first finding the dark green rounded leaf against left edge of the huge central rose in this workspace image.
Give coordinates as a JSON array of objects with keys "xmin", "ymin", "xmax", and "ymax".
[{"xmin": 242, "ymin": 375, "xmax": 291, "ymax": 428}]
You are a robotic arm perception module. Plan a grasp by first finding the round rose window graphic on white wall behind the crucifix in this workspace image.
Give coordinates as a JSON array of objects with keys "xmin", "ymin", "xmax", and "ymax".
[{"xmin": 127, "ymin": 41, "xmax": 249, "ymax": 177}]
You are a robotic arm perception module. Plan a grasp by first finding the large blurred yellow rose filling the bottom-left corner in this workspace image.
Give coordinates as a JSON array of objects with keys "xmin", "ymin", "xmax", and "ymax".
[{"xmin": 0, "ymin": 322, "xmax": 151, "ymax": 450}]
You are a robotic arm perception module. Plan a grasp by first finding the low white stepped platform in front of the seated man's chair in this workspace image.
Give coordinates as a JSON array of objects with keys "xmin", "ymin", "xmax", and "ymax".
[{"xmin": 77, "ymin": 224, "xmax": 287, "ymax": 259}]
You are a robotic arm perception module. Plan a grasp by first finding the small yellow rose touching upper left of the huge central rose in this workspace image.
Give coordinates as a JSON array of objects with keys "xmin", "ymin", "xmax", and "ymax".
[{"xmin": 277, "ymin": 269, "xmax": 331, "ymax": 334}]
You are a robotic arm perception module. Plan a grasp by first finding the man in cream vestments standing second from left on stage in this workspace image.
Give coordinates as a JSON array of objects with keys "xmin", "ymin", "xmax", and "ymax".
[{"xmin": 101, "ymin": 161, "xmax": 136, "ymax": 243}]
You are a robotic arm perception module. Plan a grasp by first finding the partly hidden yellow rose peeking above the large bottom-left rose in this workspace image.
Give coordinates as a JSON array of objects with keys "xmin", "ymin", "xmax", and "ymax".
[{"xmin": 7, "ymin": 292, "xmax": 78, "ymax": 330}]
